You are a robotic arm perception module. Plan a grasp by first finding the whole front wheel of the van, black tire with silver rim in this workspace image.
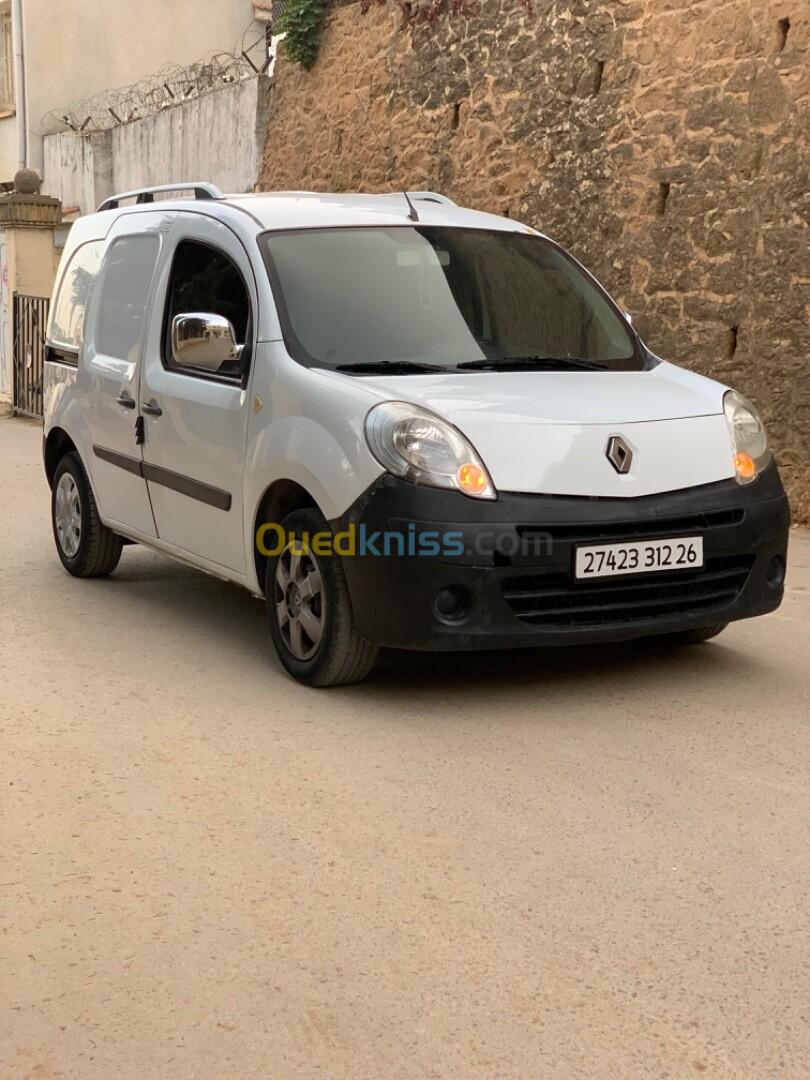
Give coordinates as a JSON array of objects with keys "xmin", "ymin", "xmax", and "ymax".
[{"xmin": 265, "ymin": 509, "xmax": 379, "ymax": 687}]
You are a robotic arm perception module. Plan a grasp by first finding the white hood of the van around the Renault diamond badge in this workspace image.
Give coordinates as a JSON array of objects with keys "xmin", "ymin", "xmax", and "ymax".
[{"xmin": 319, "ymin": 363, "xmax": 734, "ymax": 498}]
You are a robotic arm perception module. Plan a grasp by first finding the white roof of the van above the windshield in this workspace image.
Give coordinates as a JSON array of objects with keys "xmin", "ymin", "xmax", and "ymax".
[{"xmin": 87, "ymin": 191, "xmax": 536, "ymax": 233}]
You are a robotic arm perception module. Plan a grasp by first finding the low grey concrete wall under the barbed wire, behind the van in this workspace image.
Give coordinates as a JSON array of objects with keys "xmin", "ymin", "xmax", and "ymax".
[{"xmin": 43, "ymin": 78, "xmax": 269, "ymax": 213}]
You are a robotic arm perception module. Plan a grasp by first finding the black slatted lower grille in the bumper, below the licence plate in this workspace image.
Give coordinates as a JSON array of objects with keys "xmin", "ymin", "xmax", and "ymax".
[{"xmin": 501, "ymin": 552, "xmax": 754, "ymax": 626}]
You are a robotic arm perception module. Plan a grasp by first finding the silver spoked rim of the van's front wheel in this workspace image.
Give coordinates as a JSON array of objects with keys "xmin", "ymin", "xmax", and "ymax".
[{"xmin": 274, "ymin": 541, "xmax": 326, "ymax": 660}]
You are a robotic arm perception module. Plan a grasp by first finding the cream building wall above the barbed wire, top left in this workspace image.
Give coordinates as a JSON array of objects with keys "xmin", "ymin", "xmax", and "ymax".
[{"xmin": 0, "ymin": 0, "xmax": 255, "ymax": 179}]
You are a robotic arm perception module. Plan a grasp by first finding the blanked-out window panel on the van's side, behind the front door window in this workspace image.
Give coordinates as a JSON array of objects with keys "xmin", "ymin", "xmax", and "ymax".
[{"xmin": 96, "ymin": 235, "xmax": 160, "ymax": 361}]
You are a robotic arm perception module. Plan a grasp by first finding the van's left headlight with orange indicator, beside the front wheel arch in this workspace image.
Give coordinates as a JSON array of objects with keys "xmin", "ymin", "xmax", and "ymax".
[{"xmin": 366, "ymin": 402, "xmax": 497, "ymax": 499}]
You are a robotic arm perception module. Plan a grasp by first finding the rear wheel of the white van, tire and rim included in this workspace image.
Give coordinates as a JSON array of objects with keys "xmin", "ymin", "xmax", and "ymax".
[{"xmin": 51, "ymin": 453, "xmax": 123, "ymax": 578}]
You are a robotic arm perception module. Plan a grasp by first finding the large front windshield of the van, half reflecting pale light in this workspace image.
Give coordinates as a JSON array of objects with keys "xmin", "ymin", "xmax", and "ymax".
[{"xmin": 261, "ymin": 226, "xmax": 644, "ymax": 372}]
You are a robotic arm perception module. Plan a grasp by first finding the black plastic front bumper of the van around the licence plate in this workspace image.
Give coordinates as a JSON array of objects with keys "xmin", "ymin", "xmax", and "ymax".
[{"xmin": 332, "ymin": 465, "xmax": 789, "ymax": 650}]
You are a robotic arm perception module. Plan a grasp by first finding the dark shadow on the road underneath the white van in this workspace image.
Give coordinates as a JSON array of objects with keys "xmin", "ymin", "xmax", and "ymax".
[{"xmin": 104, "ymin": 550, "xmax": 762, "ymax": 708}]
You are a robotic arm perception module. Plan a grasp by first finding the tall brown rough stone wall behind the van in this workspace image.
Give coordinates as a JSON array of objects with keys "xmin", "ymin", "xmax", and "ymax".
[{"xmin": 261, "ymin": 0, "xmax": 810, "ymax": 521}]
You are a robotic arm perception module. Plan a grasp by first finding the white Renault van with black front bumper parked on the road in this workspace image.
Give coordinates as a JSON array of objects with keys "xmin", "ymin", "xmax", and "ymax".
[{"xmin": 44, "ymin": 183, "xmax": 789, "ymax": 686}]
